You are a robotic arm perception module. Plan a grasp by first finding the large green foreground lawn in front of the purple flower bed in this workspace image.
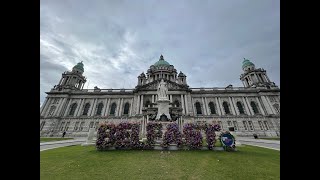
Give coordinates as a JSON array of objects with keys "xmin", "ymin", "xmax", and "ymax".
[{"xmin": 40, "ymin": 145, "xmax": 280, "ymax": 180}]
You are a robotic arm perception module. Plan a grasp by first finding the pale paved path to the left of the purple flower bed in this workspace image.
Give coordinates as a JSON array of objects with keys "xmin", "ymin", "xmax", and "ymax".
[{"xmin": 40, "ymin": 139, "xmax": 85, "ymax": 151}]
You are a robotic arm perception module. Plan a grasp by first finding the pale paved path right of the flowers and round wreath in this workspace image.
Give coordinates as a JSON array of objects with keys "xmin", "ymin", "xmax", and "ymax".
[{"xmin": 238, "ymin": 137, "xmax": 280, "ymax": 151}]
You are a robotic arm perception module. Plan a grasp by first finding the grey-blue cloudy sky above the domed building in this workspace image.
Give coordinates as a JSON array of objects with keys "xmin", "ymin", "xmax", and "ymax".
[{"xmin": 40, "ymin": 0, "xmax": 280, "ymax": 103}]
